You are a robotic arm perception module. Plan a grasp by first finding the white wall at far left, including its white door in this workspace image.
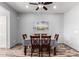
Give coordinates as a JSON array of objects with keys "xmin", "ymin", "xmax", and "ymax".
[{"xmin": 0, "ymin": 6, "xmax": 10, "ymax": 48}]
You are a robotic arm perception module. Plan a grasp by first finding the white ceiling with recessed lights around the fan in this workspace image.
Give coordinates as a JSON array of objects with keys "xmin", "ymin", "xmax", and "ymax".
[{"xmin": 7, "ymin": 2, "xmax": 79, "ymax": 13}]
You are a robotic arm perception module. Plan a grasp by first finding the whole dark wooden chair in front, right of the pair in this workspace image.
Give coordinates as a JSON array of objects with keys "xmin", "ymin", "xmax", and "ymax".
[{"xmin": 40, "ymin": 36, "xmax": 51, "ymax": 56}]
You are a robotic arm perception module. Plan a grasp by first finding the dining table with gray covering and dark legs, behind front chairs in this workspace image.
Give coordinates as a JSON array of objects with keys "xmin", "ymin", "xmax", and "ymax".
[{"xmin": 23, "ymin": 38, "xmax": 58, "ymax": 55}]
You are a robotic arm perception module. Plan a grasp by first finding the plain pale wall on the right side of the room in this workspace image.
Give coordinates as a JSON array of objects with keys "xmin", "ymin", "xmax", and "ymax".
[{"xmin": 64, "ymin": 5, "xmax": 79, "ymax": 51}]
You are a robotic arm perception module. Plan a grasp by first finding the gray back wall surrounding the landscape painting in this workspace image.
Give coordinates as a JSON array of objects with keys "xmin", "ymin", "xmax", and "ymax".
[{"xmin": 18, "ymin": 13, "xmax": 64, "ymax": 43}]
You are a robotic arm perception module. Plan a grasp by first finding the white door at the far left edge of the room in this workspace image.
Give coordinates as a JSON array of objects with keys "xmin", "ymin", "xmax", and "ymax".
[{"xmin": 0, "ymin": 16, "xmax": 7, "ymax": 48}]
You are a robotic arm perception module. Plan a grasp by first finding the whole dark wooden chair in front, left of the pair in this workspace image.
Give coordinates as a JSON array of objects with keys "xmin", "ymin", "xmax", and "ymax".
[{"xmin": 30, "ymin": 35, "xmax": 40, "ymax": 57}]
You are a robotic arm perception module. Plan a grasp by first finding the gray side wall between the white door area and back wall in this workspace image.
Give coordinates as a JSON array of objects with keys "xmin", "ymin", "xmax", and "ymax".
[{"xmin": 0, "ymin": 2, "xmax": 18, "ymax": 47}]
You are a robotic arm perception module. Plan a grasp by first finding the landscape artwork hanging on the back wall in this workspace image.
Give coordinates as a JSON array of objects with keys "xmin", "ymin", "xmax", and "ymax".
[{"xmin": 33, "ymin": 20, "xmax": 49, "ymax": 31}]
